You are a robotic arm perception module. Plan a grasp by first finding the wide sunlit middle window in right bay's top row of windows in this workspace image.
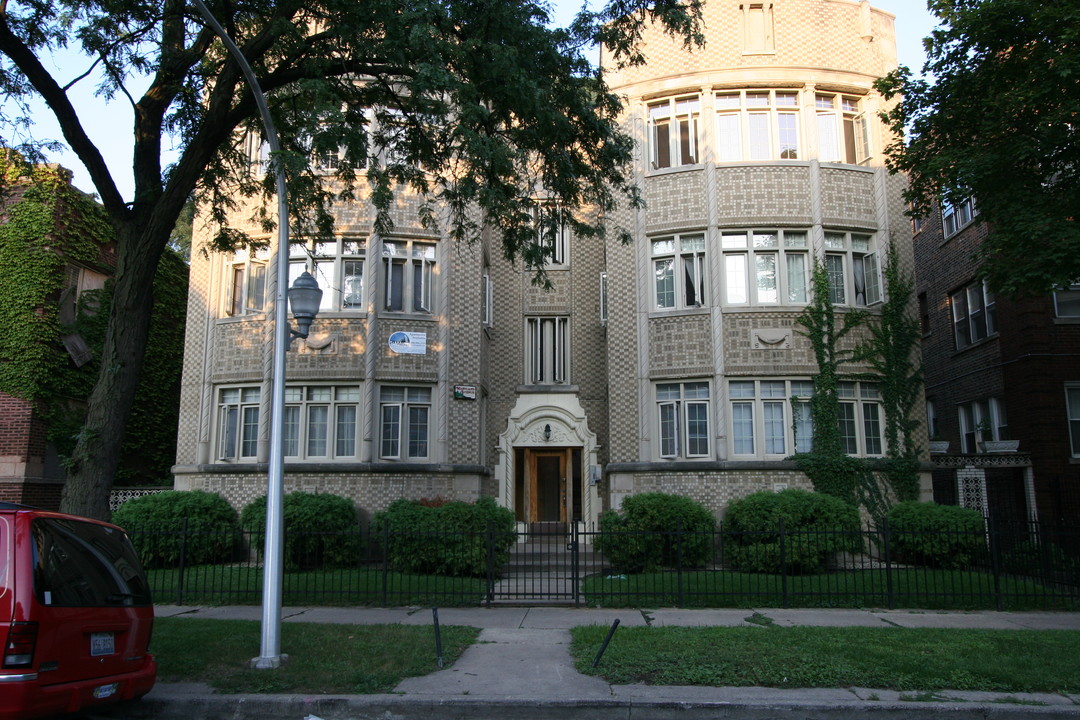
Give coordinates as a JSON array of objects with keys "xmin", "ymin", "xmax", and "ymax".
[{"xmin": 715, "ymin": 90, "xmax": 801, "ymax": 162}]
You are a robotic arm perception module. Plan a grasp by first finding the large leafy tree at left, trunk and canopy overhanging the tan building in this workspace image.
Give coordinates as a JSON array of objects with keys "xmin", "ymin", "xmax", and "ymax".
[{"xmin": 0, "ymin": 0, "xmax": 701, "ymax": 517}]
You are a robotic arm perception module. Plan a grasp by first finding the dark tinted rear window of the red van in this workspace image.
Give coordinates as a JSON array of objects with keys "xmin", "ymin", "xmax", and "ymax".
[{"xmin": 32, "ymin": 518, "xmax": 150, "ymax": 608}]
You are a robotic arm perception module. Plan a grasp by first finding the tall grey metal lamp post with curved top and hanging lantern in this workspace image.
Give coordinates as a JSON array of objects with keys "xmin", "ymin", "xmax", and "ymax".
[{"xmin": 191, "ymin": 0, "xmax": 323, "ymax": 669}]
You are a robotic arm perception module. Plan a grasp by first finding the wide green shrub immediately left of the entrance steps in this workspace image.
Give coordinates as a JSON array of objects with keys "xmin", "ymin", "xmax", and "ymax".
[{"xmin": 373, "ymin": 498, "xmax": 517, "ymax": 578}]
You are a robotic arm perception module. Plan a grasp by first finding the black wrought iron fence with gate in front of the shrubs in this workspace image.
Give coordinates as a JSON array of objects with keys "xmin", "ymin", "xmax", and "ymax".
[{"xmin": 130, "ymin": 515, "xmax": 1080, "ymax": 610}]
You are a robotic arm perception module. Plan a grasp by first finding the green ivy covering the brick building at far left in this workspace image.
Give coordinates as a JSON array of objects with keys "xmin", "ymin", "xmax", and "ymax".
[{"xmin": 0, "ymin": 153, "xmax": 188, "ymax": 485}]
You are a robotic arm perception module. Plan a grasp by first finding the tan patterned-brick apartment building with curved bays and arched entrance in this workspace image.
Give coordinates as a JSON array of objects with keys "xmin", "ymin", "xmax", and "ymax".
[{"xmin": 174, "ymin": 0, "xmax": 921, "ymax": 525}]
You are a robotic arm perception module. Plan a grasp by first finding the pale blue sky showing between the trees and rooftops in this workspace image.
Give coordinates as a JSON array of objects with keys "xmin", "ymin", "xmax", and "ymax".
[{"xmin": 4, "ymin": 0, "xmax": 935, "ymax": 200}]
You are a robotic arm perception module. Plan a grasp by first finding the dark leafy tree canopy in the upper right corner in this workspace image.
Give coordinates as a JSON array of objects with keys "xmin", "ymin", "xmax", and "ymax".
[{"xmin": 877, "ymin": 0, "xmax": 1080, "ymax": 295}]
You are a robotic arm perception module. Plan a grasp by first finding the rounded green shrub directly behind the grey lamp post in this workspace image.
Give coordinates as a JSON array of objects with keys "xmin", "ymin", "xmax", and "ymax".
[{"xmin": 240, "ymin": 491, "xmax": 363, "ymax": 570}]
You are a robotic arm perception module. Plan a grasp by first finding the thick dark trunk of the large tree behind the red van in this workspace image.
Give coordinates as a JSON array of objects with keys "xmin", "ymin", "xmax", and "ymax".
[{"xmin": 60, "ymin": 221, "xmax": 168, "ymax": 520}]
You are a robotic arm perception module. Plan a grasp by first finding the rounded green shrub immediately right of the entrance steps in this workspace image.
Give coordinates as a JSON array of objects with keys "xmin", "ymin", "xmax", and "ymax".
[{"xmin": 596, "ymin": 492, "xmax": 716, "ymax": 572}]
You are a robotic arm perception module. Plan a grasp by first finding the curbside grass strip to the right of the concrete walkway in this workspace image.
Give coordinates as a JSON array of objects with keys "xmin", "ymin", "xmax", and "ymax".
[{"xmin": 571, "ymin": 625, "xmax": 1080, "ymax": 693}]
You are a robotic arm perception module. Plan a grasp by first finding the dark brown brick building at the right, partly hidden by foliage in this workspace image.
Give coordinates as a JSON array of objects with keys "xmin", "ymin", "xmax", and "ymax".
[{"xmin": 913, "ymin": 202, "xmax": 1080, "ymax": 524}]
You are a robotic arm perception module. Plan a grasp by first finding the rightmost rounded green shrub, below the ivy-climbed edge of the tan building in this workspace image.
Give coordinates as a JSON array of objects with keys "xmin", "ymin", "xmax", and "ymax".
[{"xmin": 888, "ymin": 501, "xmax": 986, "ymax": 570}]
